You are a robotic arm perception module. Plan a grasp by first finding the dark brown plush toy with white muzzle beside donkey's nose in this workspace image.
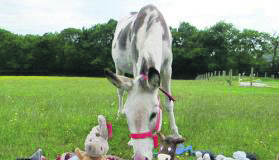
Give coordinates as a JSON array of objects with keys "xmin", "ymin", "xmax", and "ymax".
[{"xmin": 158, "ymin": 133, "xmax": 185, "ymax": 160}]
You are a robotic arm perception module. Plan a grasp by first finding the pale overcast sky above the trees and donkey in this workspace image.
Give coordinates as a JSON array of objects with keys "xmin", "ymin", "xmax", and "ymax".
[{"xmin": 0, "ymin": 0, "xmax": 279, "ymax": 35}]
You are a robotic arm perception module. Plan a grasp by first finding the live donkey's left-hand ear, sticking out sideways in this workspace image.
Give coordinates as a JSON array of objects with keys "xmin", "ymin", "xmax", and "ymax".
[{"xmin": 105, "ymin": 69, "xmax": 133, "ymax": 90}]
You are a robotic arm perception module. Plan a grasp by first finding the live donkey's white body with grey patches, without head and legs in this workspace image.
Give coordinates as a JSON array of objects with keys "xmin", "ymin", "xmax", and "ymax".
[{"xmin": 112, "ymin": 5, "xmax": 172, "ymax": 76}]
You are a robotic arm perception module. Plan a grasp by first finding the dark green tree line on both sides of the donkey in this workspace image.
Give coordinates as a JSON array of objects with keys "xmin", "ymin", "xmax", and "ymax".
[{"xmin": 0, "ymin": 19, "xmax": 279, "ymax": 78}]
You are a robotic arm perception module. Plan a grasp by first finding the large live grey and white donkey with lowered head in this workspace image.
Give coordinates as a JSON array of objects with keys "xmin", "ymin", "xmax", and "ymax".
[{"xmin": 105, "ymin": 5, "xmax": 180, "ymax": 160}]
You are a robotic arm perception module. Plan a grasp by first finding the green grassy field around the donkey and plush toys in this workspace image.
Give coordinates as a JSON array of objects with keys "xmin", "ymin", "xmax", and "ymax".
[{"xmin": 0, "ymin": 76, "xmax": 279, "ymax": 160}]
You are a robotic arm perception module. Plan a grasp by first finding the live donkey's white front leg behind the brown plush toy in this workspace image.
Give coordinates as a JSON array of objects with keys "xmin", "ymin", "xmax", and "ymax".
[{"xmin": 162, "ymin": 67, "xmax": 182, "ymax": 137}]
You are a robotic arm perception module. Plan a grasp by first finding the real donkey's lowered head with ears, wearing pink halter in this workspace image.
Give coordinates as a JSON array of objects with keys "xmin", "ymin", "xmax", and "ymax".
[{"xmin": 105, "ymin": 67, "xmax": 162, "ymax": 160}]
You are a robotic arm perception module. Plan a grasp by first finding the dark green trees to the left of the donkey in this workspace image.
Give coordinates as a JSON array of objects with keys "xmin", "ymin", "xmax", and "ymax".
[{"xmin": 0, "ymin": 20, "xmax": 117, "ymax": 76}]
